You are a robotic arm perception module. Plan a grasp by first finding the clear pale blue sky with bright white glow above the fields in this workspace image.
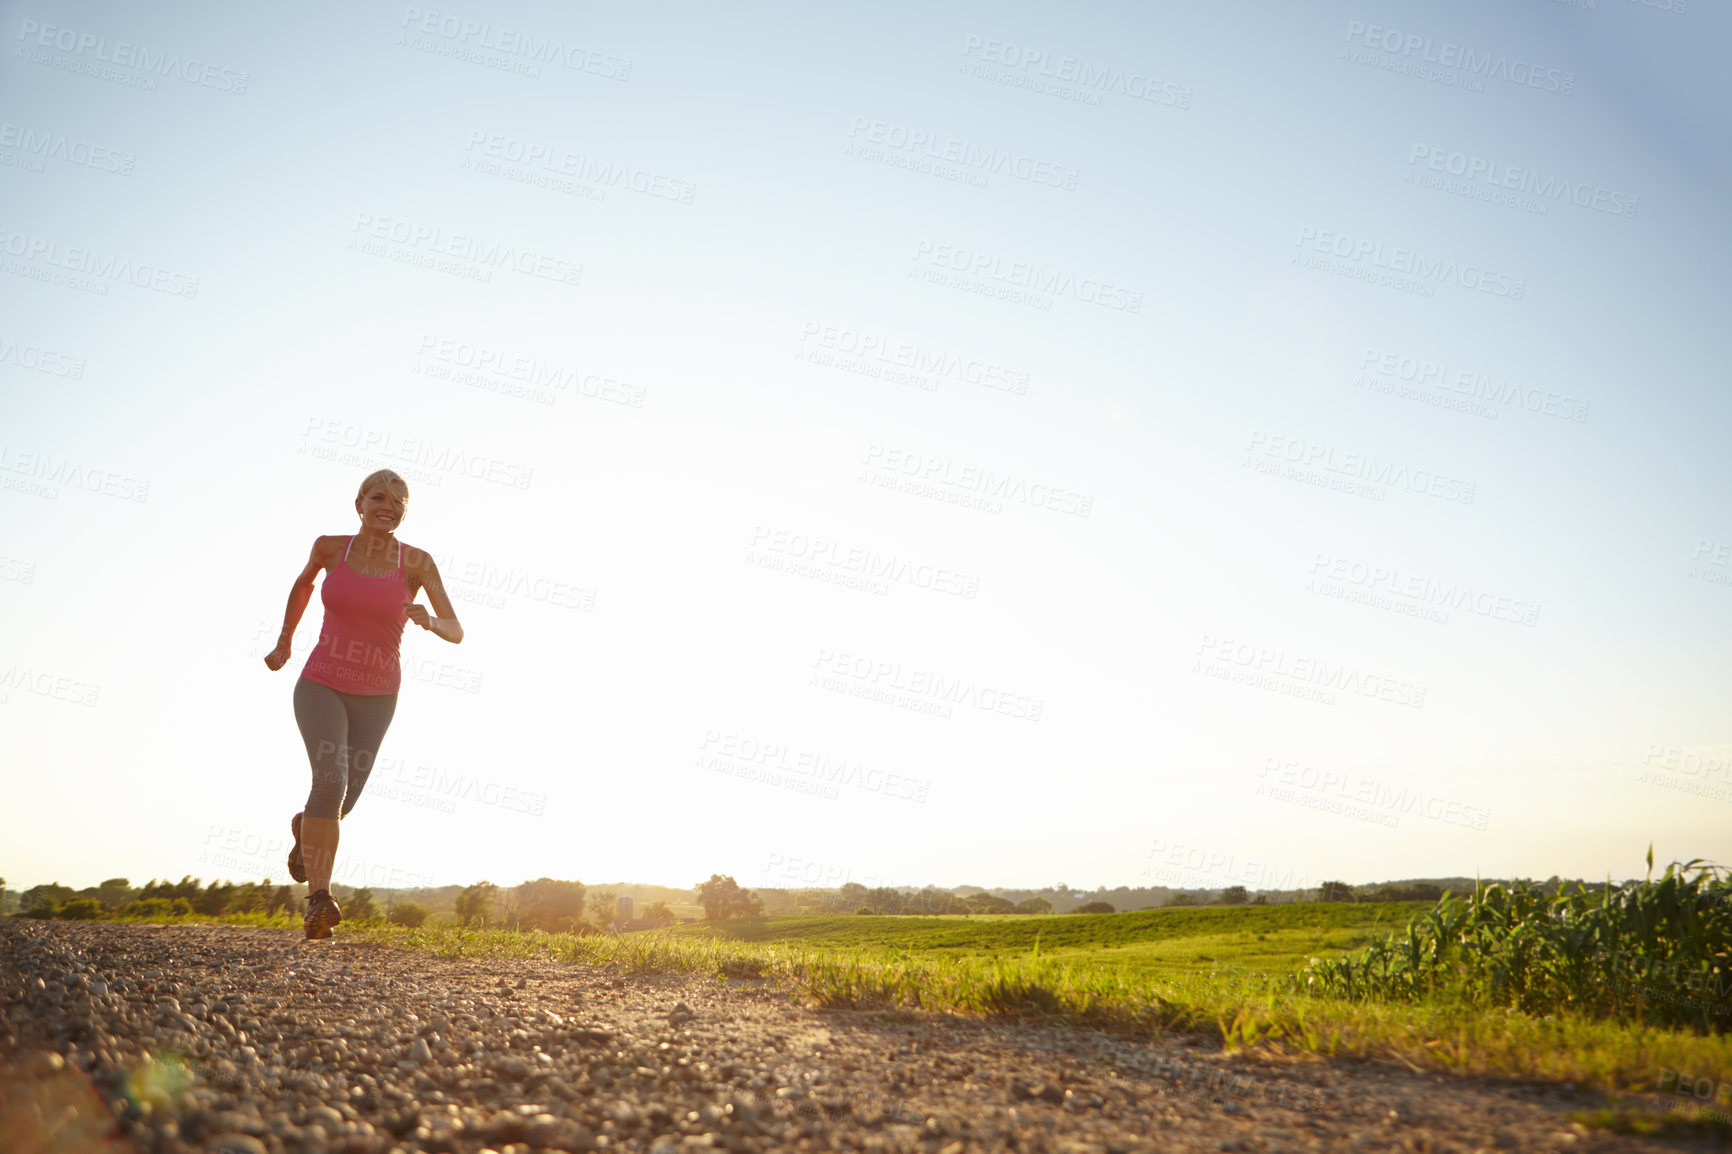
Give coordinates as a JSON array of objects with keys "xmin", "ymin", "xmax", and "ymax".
[{"xmin": 0, "ymin": 0, "xmax": 1732, "ymax": 887}]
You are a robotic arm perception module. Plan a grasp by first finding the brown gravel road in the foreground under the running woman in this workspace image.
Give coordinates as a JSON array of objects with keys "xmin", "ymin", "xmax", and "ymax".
[{"xmin": 0, "ymin": 918, "xmax": 1704, "ymax": 1154}]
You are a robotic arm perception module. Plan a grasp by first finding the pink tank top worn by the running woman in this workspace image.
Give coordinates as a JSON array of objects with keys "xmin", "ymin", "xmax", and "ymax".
[{"xmin": 301, "ymin": 537, "xmax": 409, "ymax": 697}]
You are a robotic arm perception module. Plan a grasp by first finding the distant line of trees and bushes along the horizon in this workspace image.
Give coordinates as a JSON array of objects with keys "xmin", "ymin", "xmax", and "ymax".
[{"xmin": 0, "ymin": 873, "xmax": 1604, "ymax": 932}]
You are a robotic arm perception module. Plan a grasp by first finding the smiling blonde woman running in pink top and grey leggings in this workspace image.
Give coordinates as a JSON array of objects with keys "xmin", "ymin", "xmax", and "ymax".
[{"xmin": 265, "ymin": 470, "xmax": 462, "ymax": 937}]
